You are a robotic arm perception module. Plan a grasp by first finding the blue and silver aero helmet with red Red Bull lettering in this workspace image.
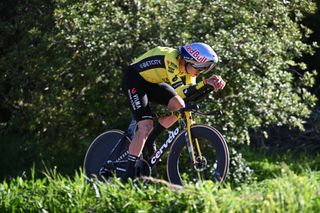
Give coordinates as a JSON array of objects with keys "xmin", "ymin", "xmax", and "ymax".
[{"xmin": 179, "ymin": 42, "xmax": 218, "ymax": 73}]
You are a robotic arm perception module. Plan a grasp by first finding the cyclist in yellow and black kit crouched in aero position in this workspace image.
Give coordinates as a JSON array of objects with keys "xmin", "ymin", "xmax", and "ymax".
[{"xmin": 122, "ymin": 43, "xmax": 225, "ymax": 181}]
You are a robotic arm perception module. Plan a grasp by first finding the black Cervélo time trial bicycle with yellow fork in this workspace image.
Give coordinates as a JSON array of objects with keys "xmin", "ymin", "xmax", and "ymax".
[{"xmin": 84, "ymin": 85, "xmax": 229, "ymax": 185}]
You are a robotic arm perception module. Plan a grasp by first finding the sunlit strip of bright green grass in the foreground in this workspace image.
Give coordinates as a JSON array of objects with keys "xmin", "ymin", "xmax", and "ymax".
[{"xmin": 0, "ymin": 167, "xmax": 320, "ymax": 212}]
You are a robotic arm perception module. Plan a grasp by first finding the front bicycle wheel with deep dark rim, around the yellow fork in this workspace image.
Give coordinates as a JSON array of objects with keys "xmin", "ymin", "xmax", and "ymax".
[{"xmin": 167, "ymin": 125, "xmax": 229, "ymax": 185}]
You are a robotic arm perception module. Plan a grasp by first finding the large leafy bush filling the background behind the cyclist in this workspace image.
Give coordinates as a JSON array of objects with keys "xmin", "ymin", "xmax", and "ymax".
[{"xmin": 0, "ymin": 0, "xmax": 317, "ymax": 178}]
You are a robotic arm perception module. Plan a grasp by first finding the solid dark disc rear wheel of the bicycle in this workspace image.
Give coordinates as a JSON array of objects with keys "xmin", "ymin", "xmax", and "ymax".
[{"xmin": 83, "ymin": 130, "xmax": 130, "ymax": 180}]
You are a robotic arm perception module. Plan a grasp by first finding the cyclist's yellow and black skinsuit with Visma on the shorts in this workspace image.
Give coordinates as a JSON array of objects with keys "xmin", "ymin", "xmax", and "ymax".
[{"xmin": 123, "ymin": 47, "xmax": 208, "ymax": 121}]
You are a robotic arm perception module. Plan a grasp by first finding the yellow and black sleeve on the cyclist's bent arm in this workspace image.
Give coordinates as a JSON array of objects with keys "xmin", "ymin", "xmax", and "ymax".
[{"xmin": 165, "ymin": 54, "xmax": 205, "ymax": 99}]
